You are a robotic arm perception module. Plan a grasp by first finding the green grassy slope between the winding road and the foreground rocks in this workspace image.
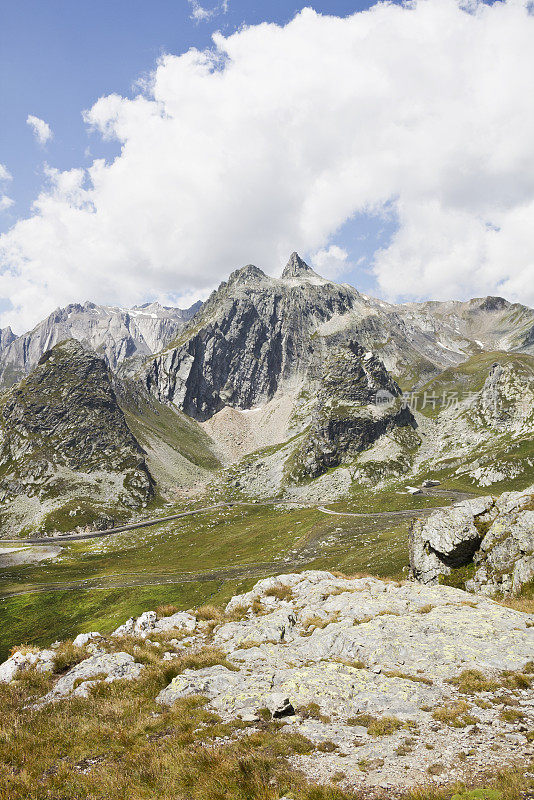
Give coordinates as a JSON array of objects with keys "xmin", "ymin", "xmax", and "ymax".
[{"xmin": 0, "ymin": 506, "xmax": 416, "ymax": 658}]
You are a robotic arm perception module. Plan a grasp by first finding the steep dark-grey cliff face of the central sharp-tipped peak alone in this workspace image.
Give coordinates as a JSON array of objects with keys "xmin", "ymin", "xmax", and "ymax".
[{"xmin": 146, "ymin": 255, "xmax": 358, "ymax": 420}]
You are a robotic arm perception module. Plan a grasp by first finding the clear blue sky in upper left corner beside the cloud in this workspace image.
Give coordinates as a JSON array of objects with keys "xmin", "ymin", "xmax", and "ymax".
[{"xmin": 0, "ymin": 0, "xmax": 376, "ymax": 231}]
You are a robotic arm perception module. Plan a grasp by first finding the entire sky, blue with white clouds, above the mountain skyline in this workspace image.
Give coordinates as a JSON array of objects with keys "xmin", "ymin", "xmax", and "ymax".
[{"xmin": 0, "ymin": 0, "xmax": 534, "ymax": 333}]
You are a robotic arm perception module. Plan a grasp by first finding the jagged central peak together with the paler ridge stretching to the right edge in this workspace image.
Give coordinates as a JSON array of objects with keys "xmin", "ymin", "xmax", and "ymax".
[{"xmin": 146, "ymin": 253, "xmax": 534, "ymax": 420}]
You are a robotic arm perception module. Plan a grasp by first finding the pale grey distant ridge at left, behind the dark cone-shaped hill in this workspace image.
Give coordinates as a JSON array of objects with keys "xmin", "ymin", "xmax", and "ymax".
[{"xmin": 0, "ymin": 303, "xmax": 201, "ymax": 386}]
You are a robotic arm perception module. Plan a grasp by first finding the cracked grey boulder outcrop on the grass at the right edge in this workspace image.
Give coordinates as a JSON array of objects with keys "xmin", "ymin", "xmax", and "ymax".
[{"xmin": 410, "ymin": 486, "xmax": 534, "ymax": 594}]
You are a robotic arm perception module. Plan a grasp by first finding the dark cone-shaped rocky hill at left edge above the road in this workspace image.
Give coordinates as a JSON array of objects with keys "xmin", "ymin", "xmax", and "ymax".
[{"xmin": 0, "ymin": 340, "xmax": 154, "ymax": 534}]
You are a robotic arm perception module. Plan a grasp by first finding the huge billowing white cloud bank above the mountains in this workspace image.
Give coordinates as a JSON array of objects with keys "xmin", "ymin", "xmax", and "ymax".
[{"xmin": 0, "ymin": 0, "xmax": 534, "ymax": 329}]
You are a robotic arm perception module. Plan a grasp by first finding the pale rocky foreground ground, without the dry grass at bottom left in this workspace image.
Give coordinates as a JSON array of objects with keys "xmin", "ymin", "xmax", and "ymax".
[{"xmin": 0, "ymin": 571, "xmax": 534, "ymax": 797}]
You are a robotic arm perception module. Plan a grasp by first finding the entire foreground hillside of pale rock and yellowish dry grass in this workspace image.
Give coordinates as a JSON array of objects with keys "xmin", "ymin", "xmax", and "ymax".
[{"xmin": 0, "ymin": 571, "xmax": 534, "ymax": 800}]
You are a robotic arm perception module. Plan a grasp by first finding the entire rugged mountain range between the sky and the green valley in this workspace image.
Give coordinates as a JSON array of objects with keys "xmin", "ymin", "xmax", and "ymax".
[{"xmin": 0, "ymin": 253, "xmax": 534, "ymax": 536}]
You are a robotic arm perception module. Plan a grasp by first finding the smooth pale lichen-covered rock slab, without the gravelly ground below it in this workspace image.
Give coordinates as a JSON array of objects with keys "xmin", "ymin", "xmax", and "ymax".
[{"xmin": 159, "ymin": 571, "xmax": 534, "ymax": 717}]
